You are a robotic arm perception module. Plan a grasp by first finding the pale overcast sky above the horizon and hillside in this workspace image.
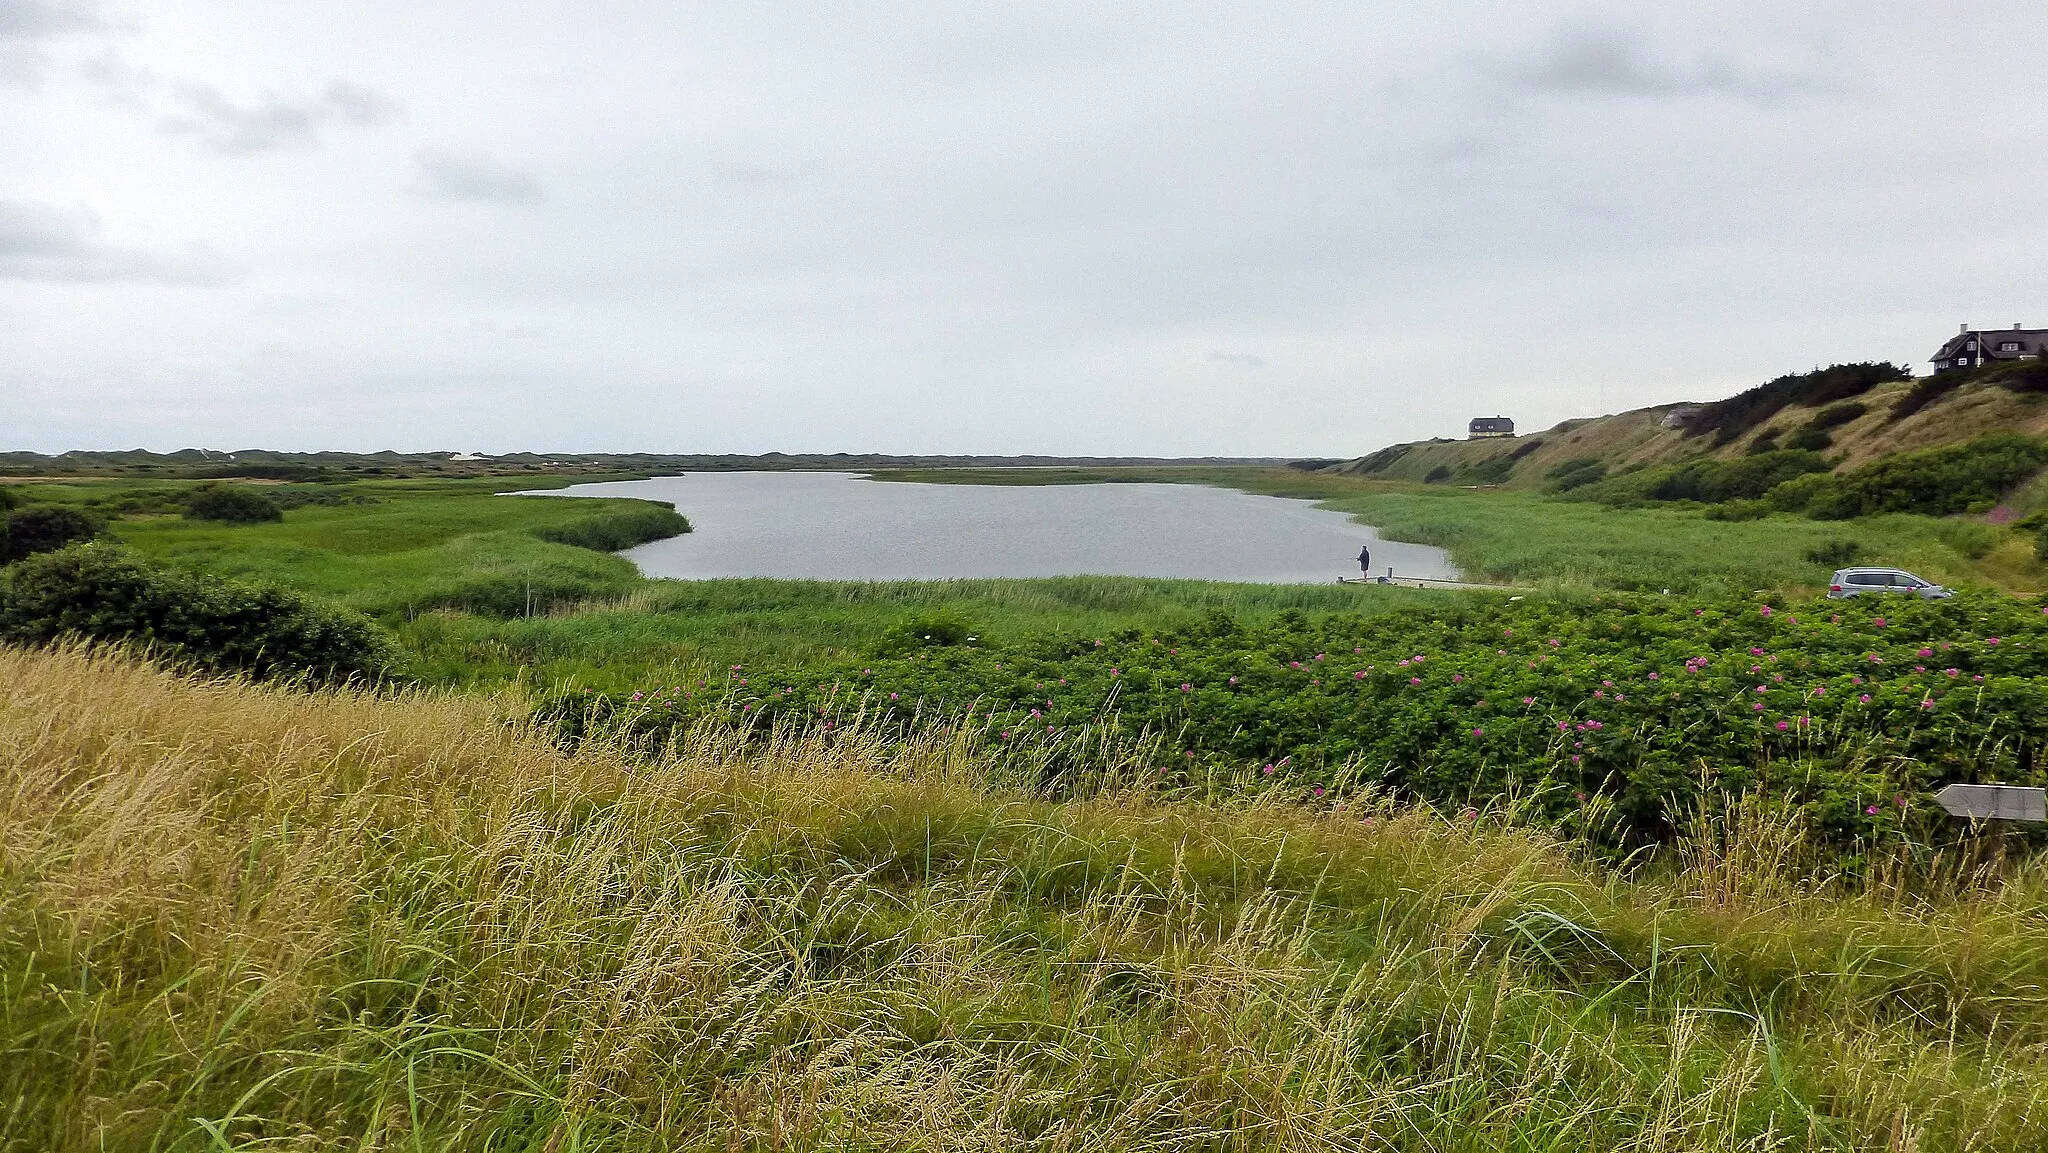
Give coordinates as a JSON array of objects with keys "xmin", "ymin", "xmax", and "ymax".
[{"xmin": 0, "ymin": 0, "xmax": 2048, "ymax": 457}]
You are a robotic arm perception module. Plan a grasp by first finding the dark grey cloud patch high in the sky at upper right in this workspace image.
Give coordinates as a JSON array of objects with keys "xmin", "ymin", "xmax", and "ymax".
[{"xmin": 1481, "ymin": 18, "xmax": 1823, "ymax": 104}]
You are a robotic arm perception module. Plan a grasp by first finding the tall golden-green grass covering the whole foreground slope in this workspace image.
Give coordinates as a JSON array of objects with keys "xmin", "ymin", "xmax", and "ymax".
[{"xmin": 12, "ymin": 649, "xmax": 2048, "ymax": 1151}]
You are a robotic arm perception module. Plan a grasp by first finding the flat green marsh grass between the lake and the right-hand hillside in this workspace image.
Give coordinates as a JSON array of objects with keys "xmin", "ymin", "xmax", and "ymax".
[{"xmin": 877, "ymin": 467, "xmax": 2044, "ymax": 596}]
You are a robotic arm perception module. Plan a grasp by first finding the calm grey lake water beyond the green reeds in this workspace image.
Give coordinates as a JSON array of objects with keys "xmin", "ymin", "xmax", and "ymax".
[{"xmin": 528, "ymin": 473, "xmax": 1458, "ymax": 584}]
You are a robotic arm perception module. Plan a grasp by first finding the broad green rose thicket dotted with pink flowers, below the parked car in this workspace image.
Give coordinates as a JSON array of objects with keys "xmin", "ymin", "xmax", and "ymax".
[{"xmin": 547, "ymin": 594, "xmax": 2048, "ymax": 844}]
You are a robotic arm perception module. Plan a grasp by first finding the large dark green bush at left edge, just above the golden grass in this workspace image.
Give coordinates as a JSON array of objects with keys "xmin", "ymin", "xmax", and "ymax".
[{"xmin": 0, "ymin": 545, "xmax": 389, "ymax": 682}]
